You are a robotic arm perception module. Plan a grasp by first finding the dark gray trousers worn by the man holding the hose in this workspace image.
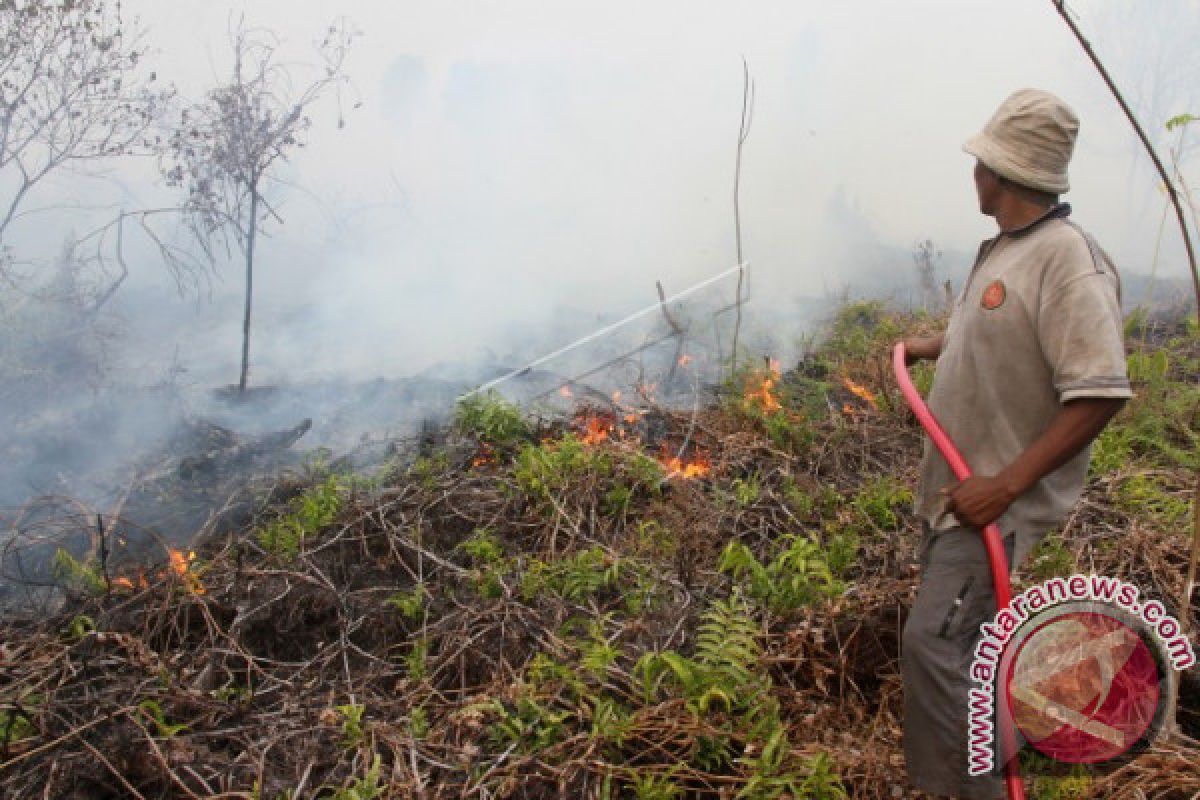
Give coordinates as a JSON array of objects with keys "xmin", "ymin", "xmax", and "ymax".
[{"xmin": 900, "ymin": 528, "xmax": 1033, "ymax": 800}]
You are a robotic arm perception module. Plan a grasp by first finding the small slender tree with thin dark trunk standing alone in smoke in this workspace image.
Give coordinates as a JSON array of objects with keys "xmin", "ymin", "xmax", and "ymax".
[{"xmin": 164, "ymin": 20, "xmax": 354, "ymax": 391}]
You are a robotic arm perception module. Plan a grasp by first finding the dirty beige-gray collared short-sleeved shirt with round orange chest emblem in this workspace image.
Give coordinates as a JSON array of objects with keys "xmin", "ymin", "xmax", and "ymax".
[{"xmin": 916, "ymin": 203, "xmax": 1133, "ymax": 554}]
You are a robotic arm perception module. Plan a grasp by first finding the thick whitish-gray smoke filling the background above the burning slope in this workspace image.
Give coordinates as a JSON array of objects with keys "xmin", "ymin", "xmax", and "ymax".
[{"xmin": 4, "ymin": 0, "xmax": 1200, "ymax": 585}]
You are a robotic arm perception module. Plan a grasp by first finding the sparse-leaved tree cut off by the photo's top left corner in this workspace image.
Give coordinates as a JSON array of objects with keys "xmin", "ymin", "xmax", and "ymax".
[{"xmin": 0, "ymin": 0, "xmax": 169, "ymax": 269}]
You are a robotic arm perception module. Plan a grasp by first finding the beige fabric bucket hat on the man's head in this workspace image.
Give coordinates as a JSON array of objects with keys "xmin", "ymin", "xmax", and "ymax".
[{"xmin": 962, "ymin": 89, "xmax": 1079, "ymax": 194}]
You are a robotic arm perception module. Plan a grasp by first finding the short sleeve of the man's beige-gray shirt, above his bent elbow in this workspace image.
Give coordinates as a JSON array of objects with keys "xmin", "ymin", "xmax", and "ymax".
[{"xmin": 1038, "ymin": 242, "xmax": 1133, "ymax": 403}]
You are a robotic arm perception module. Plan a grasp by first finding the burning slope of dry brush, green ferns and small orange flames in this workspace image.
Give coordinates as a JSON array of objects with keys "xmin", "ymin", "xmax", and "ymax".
[{"xmin": 0, "ymin": 306, "xmax": 1200, "ymax": 799}]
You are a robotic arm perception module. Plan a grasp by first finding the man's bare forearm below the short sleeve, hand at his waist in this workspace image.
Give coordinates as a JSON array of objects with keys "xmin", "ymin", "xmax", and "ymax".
[{"xmin": 942, "ymin": 397, "xmax": 1126, "ymax": 528}]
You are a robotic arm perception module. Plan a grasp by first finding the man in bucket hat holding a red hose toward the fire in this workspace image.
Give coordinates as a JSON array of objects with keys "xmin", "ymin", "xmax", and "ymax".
[{"xmin": 901, "ymin": 89, "xmax": 1132, "ymax": 798}]
